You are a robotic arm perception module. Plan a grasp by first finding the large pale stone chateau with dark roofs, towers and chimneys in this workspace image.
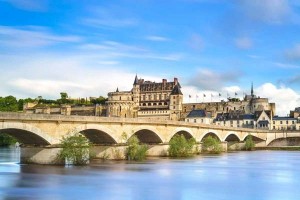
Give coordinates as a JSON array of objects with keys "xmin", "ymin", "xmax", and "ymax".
[{"xmin": 106, "ymin": 76, "xmax": 183, "ymax": 120}]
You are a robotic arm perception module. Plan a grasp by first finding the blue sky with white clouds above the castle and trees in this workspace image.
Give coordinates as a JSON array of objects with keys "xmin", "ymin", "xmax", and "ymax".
[{"xmin": 0, "ymin": 0, "xmax": 300, "ymax": 116}]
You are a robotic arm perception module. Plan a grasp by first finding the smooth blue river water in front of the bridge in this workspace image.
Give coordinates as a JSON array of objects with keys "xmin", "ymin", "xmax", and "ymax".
[{"xmin": 0, "ymin": 148, "xmax": 300, "ymax": 200}]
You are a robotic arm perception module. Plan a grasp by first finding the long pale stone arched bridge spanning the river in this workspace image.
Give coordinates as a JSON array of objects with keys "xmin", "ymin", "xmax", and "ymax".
[{"xmin": 0, "ymin": 112, "xmax": 300, "ymax": 162}]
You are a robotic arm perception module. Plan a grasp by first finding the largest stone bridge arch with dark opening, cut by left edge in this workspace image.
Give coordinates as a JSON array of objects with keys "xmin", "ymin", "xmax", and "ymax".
[{"xmin": 0, "ymin": 122, "xmax": 56, "ymax": 145}]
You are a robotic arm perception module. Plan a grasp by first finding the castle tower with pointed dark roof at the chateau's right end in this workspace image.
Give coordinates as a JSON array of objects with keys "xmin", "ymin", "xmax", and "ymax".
[{"xmin": 169, "ymin": 78, "xmax": 183, "ymax": 120}]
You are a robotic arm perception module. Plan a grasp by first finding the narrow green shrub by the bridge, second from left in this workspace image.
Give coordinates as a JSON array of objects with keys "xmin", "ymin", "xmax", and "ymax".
[{"xmin": 126, "ymin": 135, "xmax": 147, "ymax": 161}]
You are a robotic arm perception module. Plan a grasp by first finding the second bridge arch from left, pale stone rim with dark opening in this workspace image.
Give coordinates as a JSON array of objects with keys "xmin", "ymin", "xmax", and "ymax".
[{"xmin": 73, "ymin": 124, "xmax": 118, "ymax": 144}]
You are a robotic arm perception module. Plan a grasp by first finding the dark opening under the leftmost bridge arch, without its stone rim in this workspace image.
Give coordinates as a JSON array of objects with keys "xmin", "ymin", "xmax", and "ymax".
[{"xmin": 0, "ymin": 128, "xmax": 50, "ymax": 146}]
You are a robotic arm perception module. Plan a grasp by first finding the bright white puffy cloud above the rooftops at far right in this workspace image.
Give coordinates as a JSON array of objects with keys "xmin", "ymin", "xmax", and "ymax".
[{"xmin": 255, "ymin": 83, "xmax": 300, "ymax": 116}]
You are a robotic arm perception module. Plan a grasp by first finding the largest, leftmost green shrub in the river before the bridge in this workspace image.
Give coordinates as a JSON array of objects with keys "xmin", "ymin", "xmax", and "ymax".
[{"xmin": 58, "ymin": 133, "xmax": 90, "ymax": 165}]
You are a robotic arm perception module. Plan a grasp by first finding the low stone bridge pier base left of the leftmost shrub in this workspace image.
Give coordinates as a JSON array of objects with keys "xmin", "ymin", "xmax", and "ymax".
[{"xmin": 20, "ymin": 146, "xmax": 62, "ymax": 165}]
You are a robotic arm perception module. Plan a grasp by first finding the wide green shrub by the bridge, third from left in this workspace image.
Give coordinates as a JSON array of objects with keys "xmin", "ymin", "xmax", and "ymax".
[{"xmin": 168, "ymin": 135, "xmax": 196, "ymax": 157}]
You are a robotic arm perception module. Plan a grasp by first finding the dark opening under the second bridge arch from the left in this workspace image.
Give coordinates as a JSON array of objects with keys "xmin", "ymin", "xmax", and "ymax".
[{"xmin": 80, "ymin": 129, "xmax": 117, "ymax": 144}]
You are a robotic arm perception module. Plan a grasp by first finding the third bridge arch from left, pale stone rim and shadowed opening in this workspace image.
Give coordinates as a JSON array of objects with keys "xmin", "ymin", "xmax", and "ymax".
[{"xmin": 128, "ymin": 126, "xmax": 163, "ymax": 144}]
